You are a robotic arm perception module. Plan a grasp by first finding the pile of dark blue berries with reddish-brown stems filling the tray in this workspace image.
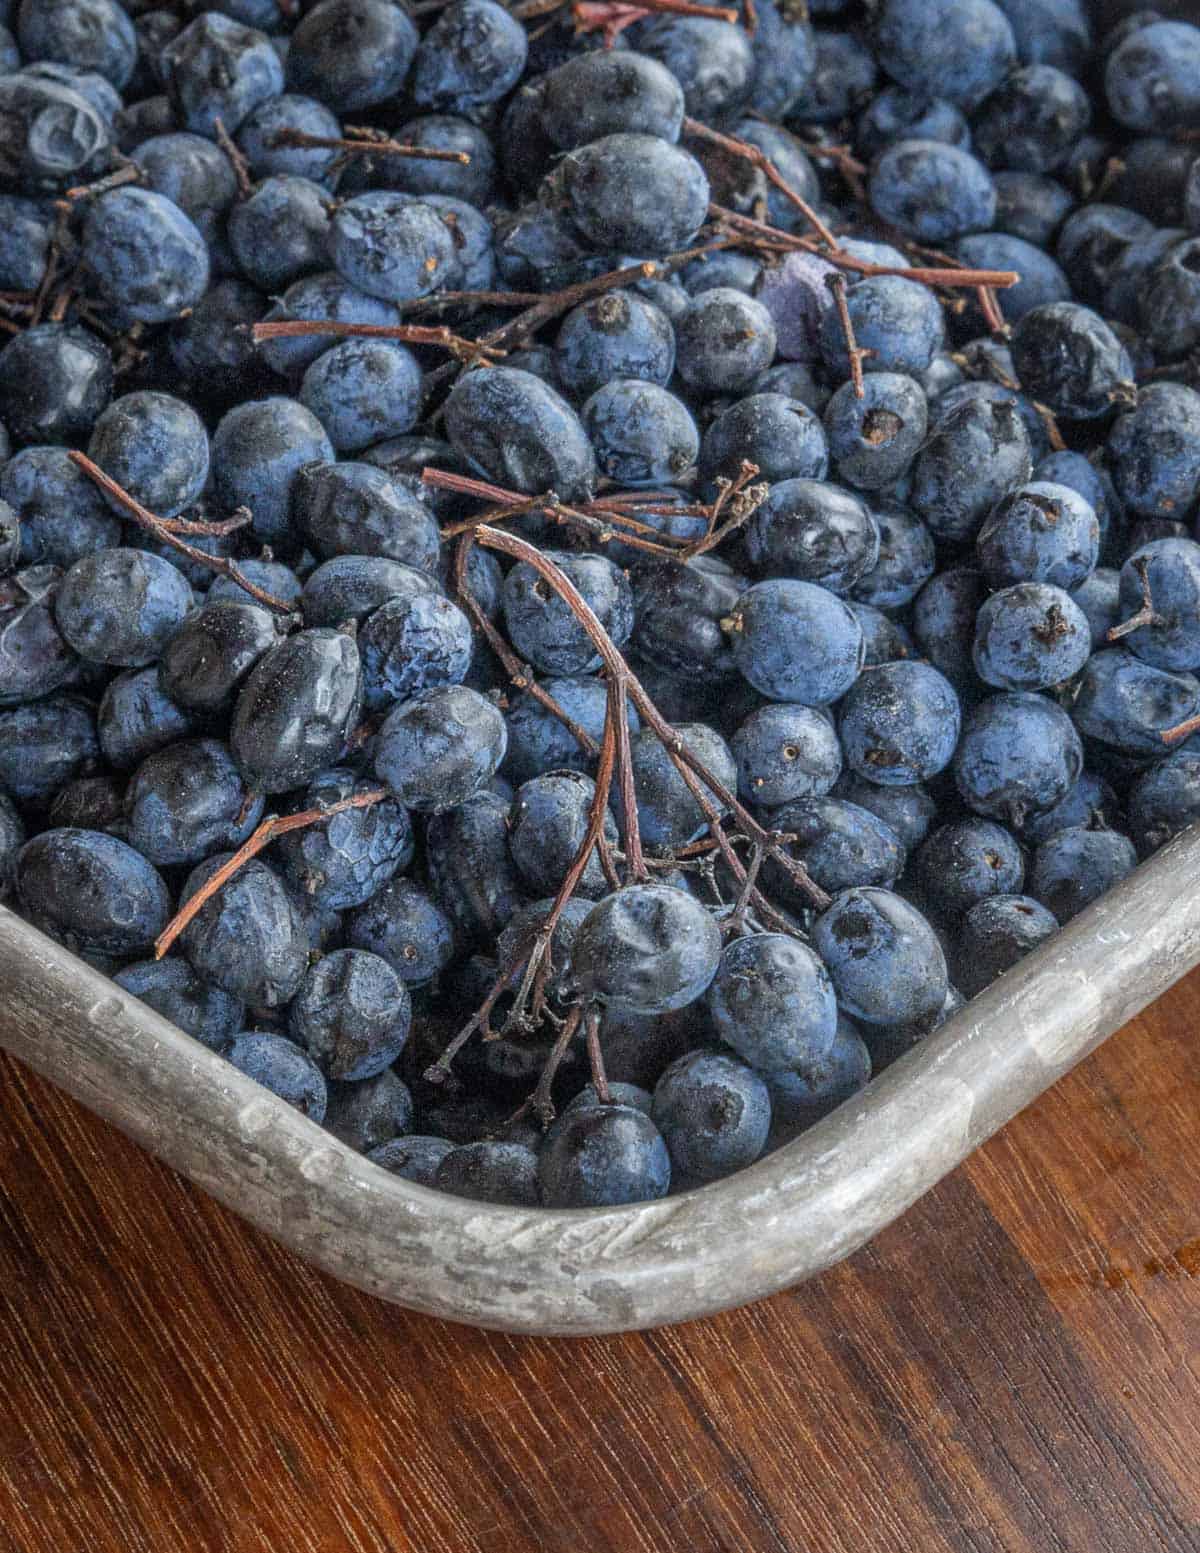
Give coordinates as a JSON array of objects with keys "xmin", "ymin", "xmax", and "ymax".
[{"xmin": 0, "ymin": 0, "xmax": 1200, "ymax": 1207}]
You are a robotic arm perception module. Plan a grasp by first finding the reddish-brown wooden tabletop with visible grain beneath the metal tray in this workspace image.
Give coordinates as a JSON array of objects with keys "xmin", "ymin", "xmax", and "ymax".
[{"xmin": 0, "ymin": 972, "xmax": 1200, "ymax": 1553}]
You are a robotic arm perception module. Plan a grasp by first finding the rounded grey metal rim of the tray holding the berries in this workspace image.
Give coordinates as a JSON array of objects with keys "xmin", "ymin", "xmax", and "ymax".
[{"xmin": 0, "ymin": 828, "xmax": 1200, "ymax": 1336}]
